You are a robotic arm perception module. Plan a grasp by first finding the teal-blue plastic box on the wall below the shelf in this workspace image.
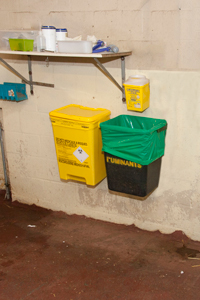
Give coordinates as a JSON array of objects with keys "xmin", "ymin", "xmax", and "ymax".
[{"xmin": 0, "ymin": 82, "xmax": 28, "ymax": 102}]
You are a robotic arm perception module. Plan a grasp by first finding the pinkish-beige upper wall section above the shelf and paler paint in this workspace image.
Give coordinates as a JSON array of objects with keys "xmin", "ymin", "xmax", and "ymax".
[{"xmin": 0, "ymin": 0, "xmax": 200, "ymax": 70}]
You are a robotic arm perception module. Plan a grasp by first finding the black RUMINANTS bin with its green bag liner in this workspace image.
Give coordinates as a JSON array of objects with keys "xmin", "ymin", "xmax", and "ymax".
[{"xmin": 100, "ymin": 115, "xmax": 167, "ymax": 197}]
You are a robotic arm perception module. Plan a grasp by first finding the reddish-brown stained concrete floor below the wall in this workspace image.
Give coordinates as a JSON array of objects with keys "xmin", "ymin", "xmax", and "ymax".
[{"xmin": 0, "ymin": 191, "xmax": 200, "ymax": 300}]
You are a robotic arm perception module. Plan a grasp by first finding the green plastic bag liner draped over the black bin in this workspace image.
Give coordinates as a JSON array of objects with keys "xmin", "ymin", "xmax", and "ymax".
[{"xmin": 100, "ymin": 115, "xmax": 167, "ymax": 165}]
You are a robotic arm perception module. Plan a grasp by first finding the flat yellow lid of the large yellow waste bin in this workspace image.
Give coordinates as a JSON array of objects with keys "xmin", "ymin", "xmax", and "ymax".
[{"xmin": 49, "ymin": 104, "xmax": 111, "ymax": 123}]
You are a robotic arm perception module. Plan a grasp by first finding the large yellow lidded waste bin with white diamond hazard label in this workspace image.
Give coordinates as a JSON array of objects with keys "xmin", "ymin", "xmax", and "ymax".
[{"xmin": 49, "ymin": 104, "xmax": 111, "ymax": 186}]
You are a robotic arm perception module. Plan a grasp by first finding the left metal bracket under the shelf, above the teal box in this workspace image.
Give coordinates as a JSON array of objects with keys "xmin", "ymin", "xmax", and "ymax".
[{"xmin": 0, "ymin": 56, "xmax": 54, "ymax": 95}]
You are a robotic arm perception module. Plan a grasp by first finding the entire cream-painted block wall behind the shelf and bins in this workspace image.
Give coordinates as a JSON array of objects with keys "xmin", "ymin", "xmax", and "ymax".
[{"xmin": 0, "ymin": 0, "xmax": 200, "ymax": 240}]
